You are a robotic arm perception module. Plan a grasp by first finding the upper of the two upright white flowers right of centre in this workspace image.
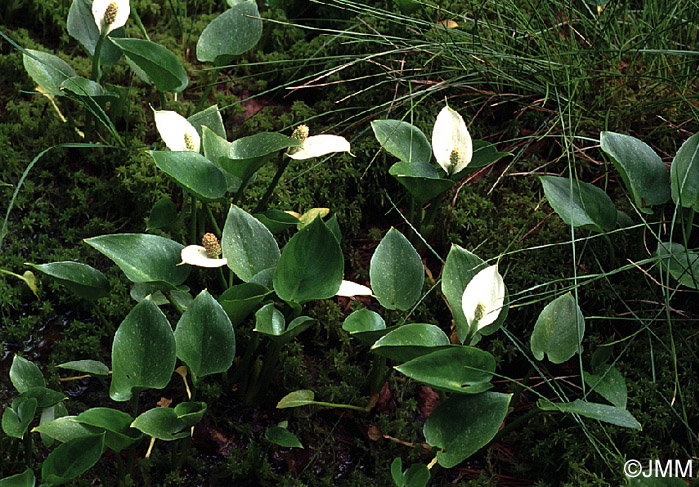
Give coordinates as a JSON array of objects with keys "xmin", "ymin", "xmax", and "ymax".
[{"xmin": 432, "ymin": 107, "xmax": 473, "ymax": 174}]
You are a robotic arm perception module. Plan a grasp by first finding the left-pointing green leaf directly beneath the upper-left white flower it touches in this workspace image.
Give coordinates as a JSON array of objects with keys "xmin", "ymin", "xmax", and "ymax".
[{"xmin": 148, "ymin": 151, "xmax": 228, "ymax": 202}]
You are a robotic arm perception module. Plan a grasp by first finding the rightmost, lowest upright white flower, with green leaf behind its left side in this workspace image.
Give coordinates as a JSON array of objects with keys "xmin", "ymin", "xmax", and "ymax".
[{"xmin": 461, "ymin": 265, "xmax": 505, "ymax": 332}]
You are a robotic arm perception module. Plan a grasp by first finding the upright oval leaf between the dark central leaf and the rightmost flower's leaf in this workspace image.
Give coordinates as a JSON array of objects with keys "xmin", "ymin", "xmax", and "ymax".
[{"xmin": 369, "ymin": 228, "xmax": 425, "ymax": 311}]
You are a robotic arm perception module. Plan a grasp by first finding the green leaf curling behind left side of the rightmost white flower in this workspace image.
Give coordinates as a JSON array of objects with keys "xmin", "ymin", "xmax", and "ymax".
[{"xmin": 442, "ymin": 244, "xmax": 488, "ymax": 343}]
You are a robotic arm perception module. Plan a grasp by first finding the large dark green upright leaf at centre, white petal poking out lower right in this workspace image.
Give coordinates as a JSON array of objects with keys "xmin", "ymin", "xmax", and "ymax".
[{"xmin": 274, "ymin": 218, "xmax": 345, "ymax": 303}]
